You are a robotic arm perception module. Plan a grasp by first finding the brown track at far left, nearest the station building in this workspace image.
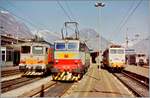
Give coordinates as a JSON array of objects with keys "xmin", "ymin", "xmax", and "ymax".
[{"xmin": 1, "ymin": 69, "xmax": 21, "ymax": 77}]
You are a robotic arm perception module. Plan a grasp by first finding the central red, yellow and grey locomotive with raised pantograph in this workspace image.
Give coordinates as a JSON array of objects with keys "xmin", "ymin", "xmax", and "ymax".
[{"xmin": 51, "ymin": 22, "xmax": 90, "ymax": 81}]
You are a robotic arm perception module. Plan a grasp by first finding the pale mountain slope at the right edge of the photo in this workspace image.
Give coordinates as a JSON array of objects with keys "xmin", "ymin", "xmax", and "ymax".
[{"xmin": 131, "ymin": 36, "xmax": 150, "ymax": 56}]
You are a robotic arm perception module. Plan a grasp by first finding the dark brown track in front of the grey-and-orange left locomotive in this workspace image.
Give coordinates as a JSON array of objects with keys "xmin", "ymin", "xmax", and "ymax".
[{"xmin": 1, "ymin": 77, "xmax": 41, "ymax": 93}]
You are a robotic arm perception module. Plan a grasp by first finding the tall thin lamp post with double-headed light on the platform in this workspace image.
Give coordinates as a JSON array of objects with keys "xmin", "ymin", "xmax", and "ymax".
[{"xmin": 94, "ymin": 2, "xmax": 105, "ymax": 66}]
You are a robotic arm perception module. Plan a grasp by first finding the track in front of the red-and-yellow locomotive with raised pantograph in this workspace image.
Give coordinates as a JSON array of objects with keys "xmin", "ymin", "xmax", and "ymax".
[{"xmin": 19, "ymin": 81, "xmax": 73, "ymax": 97}]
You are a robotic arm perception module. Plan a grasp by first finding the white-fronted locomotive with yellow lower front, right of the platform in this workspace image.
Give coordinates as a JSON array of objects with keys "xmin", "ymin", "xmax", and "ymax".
[{"xmin": 102, "ymin": 45, "xmax": 125, "ymax": 71}]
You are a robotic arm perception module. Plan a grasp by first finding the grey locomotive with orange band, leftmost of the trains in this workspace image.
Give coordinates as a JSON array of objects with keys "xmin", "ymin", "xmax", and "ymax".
[{"xmin": 19, "ymin": 42, "xmax": 53, "ymax": 75}]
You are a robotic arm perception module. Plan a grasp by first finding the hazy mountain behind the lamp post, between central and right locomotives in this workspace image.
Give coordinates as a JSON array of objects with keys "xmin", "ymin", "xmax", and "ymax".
[{"xmin": 79, "ymin": 28, "xmax": 111, "ymax": 51}]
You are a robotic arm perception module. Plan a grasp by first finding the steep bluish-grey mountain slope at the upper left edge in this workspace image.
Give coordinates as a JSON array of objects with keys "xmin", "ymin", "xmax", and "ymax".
[{"xmin": 0, "ymin": 11, "xmax": 33, "ymax": 39}]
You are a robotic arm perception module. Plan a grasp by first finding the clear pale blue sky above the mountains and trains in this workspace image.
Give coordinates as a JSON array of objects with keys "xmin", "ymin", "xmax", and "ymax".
[{"xmin": 0, "ymin": 0, "xmax": 150, "ymax": 44}]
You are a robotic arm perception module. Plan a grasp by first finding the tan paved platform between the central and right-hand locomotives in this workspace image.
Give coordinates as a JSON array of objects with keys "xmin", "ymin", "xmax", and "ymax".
[{"xmin": 63, "ymin": 64, "xmax": 133, "ymax": 98}]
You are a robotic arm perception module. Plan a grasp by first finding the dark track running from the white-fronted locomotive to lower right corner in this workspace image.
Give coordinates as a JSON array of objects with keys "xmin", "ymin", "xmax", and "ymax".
[{"xmin": 113, "ymin": 71, "xmax": 149, "ymax": 97}]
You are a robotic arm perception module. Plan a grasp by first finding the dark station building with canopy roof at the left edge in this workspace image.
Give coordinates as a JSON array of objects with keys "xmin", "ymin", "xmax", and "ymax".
[{"xmin": 0, "ymin": 34, "xmax": 26, "ymax": 66}]
